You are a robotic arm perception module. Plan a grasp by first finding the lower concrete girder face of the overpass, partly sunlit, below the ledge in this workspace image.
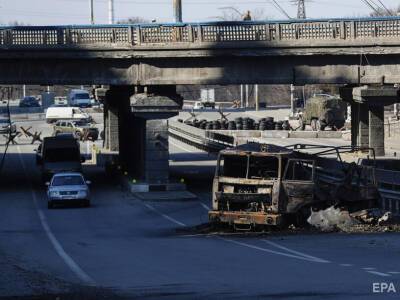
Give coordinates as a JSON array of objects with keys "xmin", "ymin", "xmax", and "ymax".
[{"xmin": 0, "ymin": 50, "xmax": 400, "ymax": 85}]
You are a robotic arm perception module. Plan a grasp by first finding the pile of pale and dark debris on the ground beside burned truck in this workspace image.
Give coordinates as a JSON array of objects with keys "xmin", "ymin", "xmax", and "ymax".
[{"xmin": 307, "ymin": 206, "xmax": 400, "ymax": 233}]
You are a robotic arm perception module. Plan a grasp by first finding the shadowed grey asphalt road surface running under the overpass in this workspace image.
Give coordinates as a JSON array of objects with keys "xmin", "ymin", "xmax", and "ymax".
[{"xmin": 0, "ymin": 118, "xmax": 400, "ymax": 299}]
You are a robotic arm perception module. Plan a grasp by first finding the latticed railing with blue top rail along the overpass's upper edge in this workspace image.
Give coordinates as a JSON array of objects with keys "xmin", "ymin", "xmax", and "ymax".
[{"xmin": 0, "ymin": 17, "xmax": 400, "ymax": 49}]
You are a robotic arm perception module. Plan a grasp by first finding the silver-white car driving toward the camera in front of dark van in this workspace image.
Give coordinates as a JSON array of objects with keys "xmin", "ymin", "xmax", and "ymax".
[{"xmin": 46, "ymin": 173, "xmax": 90, "ymax": 209}]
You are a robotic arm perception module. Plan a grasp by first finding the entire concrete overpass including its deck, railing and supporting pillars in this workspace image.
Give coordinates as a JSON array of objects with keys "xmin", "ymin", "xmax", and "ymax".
[{"xmin": 0, "ymin": 17, "xmax": 400, "ymax": 185}]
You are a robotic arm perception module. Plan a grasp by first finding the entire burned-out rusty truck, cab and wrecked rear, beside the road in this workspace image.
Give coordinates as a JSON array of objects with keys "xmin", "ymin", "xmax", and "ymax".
[{"xmin": 209, "ymin": 143, "xmax": 378, "ymax": 230}]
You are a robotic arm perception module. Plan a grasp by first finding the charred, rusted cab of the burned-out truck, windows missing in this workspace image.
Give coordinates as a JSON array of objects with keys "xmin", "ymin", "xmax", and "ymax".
[{"xmin": 209, "ymin": 143, "xmax": 315, "ymax": 230}]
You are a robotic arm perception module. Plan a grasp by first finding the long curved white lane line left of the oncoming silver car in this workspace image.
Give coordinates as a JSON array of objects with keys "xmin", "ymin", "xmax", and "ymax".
[{"xmin": 17, "ymin": 146, "xmax": 96, "ymax": 286}]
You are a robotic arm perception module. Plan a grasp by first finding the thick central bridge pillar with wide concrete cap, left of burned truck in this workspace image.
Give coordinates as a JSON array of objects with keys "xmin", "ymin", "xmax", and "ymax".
[{"xmin": 111, "ymin": 86, "xmax": 182, "ymax": 184}]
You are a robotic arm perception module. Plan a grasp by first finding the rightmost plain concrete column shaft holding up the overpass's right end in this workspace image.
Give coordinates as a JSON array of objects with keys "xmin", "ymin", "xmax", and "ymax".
[{"xmin": 368, "ymin": 106, "xmax": 385, "ymax": 156}]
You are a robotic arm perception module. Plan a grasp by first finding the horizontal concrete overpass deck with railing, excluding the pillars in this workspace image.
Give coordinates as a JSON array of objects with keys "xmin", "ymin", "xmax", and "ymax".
[{"xmin": 0, "ymin": 17, "xmax": 400, "ymax": 85}]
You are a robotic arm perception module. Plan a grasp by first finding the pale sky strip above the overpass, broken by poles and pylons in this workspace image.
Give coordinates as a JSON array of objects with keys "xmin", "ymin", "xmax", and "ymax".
[{"xmin": 0, "ymin": 0, "xmax": 400, "ymax": 25}]
